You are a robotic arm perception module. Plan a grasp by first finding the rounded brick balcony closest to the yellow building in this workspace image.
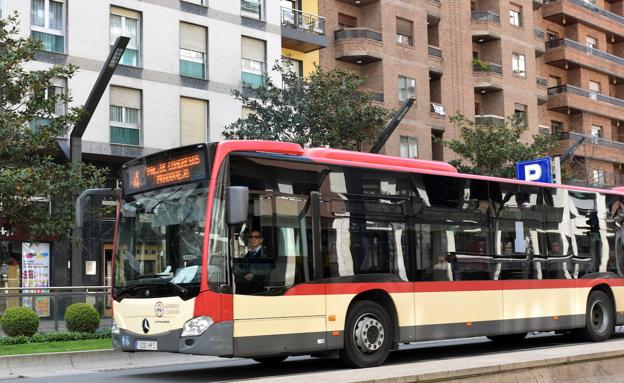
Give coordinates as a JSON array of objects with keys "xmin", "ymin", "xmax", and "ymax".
[{"xmin": 334, "ymin": 28, "xmax": 383, "ymax": 65}]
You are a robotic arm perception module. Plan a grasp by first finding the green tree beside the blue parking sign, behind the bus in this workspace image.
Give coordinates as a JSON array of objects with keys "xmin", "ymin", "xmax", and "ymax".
[{"xmin": 444, "ymin": 114, "xmax": 555, "ymax": 178}]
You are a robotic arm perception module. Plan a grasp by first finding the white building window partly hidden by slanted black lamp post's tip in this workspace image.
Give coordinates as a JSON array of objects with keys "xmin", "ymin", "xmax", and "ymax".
[{"xmin": 110, "ymin": 7, "xmax": 141, "ymax": 66}]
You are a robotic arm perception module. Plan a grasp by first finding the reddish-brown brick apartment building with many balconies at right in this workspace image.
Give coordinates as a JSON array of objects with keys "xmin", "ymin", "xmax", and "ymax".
[{"xmin": 318, "ymin": 0, "xmax": 624, "ymax": 186}]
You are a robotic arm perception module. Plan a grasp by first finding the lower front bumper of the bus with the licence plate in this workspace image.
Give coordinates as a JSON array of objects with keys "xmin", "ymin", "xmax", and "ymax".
[{"xmin": 112, "ymin": 321, "xmax": 234, "ymax": 356}]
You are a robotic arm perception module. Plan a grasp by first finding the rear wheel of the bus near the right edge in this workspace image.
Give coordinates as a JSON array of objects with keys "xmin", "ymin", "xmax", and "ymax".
[{"xmin": 579, "ymin": 290, "xmax": 615, "ymax": 342}]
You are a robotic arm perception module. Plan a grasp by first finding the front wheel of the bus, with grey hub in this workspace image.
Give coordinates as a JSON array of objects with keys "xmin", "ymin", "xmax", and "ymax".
[{"xmin": 340, "ymin": 300, "xmax": 394, "ymax": 368}]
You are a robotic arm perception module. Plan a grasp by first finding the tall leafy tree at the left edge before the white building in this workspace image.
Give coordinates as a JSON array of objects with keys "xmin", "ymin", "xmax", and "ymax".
[{"xmin": 0, "ymin": 14, "xmax": 105, "ymax": 238}]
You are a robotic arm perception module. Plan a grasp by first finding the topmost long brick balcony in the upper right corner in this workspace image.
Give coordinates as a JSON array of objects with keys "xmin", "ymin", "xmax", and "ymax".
[{"xmin": 542, "ymin": 0, "xmax": 624, "ymax": 36}]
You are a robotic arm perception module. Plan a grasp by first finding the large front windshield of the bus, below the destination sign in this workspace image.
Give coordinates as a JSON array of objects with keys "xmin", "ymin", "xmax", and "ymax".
[{"xmin": 114, "ymin": 182, "xmax": 208, "ymax": 299}]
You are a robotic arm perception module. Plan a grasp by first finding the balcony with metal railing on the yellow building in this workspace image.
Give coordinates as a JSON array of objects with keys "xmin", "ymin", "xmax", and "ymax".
[{"xmin": 281, "ymin": 7, "xmax": 327, "ymax": 53}]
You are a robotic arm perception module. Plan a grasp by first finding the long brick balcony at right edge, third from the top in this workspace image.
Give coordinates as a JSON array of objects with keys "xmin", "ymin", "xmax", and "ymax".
[{"xmin": 547, "ymin": 85, "xmax": 624, "ymax": 120}]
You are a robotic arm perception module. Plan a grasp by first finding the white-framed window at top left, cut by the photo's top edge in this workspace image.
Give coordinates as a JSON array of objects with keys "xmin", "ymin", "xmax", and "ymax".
[{"xmin": 30, "ymin": 0, "xmax": 65, "ymax": 53}]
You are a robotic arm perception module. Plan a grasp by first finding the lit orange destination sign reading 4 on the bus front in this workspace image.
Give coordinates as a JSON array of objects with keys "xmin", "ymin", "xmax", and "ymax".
[{"xmin": 124, "ymin": 150, "xmax": 207, "ymax": 194}]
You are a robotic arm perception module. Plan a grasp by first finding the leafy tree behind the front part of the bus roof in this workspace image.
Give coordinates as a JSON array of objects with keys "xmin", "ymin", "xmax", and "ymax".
[{"xmin": 223, "ymin": 63, "xmax": 392, "ymax": 150}]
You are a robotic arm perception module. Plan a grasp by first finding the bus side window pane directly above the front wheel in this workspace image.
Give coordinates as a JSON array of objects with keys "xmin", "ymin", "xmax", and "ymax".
[{"xmin": 320, "ymin": 168, "xmax": 409, "ymax": 281}]
